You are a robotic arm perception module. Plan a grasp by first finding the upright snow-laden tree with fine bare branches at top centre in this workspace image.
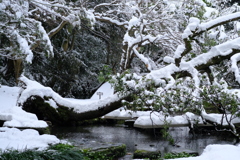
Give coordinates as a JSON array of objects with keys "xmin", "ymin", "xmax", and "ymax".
[{"xmin": 93, "ymin": 1, "xmax": 181, "ymax": 71}]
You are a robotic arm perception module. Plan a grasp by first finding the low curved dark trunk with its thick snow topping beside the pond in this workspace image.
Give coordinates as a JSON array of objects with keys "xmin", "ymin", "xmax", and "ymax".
[{"xmin": 18, "ymin": 77, "xmax": 127, "ymax": 125}]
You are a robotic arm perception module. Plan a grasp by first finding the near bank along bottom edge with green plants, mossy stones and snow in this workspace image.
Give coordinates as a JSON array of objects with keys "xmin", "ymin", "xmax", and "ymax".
[{"xmin": 0, "ymin": 144, "xmax": 240, "ymax": 160}]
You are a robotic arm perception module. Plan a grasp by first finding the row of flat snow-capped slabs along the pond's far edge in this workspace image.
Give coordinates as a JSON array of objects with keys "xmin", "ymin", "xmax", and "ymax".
[{"xmin": 104, "ymin": 109, "xmax": 240, "ymax": 128}]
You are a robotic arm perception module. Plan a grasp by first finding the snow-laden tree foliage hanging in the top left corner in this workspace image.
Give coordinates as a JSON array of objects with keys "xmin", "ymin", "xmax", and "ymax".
[{"xmin": 0, "ymin": 0, "xmax": 88, "ymax": 84}]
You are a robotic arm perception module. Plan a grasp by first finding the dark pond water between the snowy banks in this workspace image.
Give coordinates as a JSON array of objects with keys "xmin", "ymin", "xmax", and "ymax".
[{"xmin": 52, "ymin": 125, "xmax": 234, "ymax": 154}]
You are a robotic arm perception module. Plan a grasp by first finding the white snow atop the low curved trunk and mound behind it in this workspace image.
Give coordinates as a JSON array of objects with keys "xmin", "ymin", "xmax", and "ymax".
[{"xmin": 18, "ymin": 77, "xmax": 117, "ymax": 113}]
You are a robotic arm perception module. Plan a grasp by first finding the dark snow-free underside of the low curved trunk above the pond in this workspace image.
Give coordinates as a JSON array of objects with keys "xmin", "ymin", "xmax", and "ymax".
[{"xmin": 22, "ymin": 96, "xmax": 126, "ymax": 126}]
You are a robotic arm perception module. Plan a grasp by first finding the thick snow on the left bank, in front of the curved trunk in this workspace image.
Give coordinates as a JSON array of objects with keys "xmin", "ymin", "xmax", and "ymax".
[{"xmin": 0, "ymin": 86, "xmax": 60, "ymax": 151}]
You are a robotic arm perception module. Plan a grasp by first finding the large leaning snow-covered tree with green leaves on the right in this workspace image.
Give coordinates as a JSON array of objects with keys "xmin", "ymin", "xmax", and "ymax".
[{"xmin": 109, "ymin": 0, "xmax": 240, "ymax": 136}]
